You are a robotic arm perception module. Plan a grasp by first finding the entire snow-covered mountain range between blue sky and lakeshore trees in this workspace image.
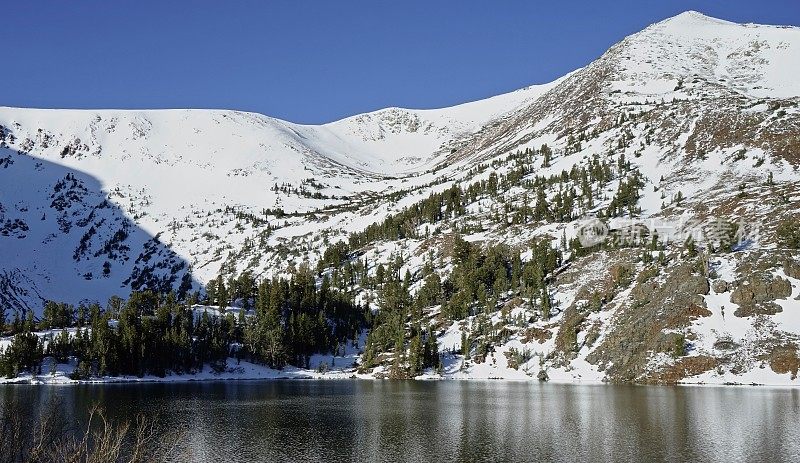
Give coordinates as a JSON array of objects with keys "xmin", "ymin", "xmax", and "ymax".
[{"xmin": 0, "ymin": 12, "xmax": 800, "ymax": 384}]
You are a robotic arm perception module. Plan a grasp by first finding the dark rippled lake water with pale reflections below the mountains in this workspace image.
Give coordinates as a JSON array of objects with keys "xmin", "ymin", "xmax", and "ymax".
[{"xmin": 0, "ymin": 380, "xmax": 800, "ymax": 462}]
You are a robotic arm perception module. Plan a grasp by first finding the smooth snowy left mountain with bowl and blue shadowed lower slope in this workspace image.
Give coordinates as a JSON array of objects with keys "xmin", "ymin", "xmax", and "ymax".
[{"xmin": 0, "ymin": 71, "xmax": 553, "ymax": 307}]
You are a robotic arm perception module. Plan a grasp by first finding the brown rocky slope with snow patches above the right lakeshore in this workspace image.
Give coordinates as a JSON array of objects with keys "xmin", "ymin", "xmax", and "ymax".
[{"xmin": 545, "ymin": 249, "xmax": 800, "ymax": 384}]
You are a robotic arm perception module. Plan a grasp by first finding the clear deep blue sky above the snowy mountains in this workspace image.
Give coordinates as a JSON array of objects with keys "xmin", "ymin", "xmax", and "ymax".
[{"xmin": 0, "ymin": 0, "xmax": 800, "ymax": 123}]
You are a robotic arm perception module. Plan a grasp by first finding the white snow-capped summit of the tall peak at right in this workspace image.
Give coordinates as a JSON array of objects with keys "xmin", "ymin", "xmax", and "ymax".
[{"xmin": 617, "ymin": 11, "xmax": 800, "ymax": 98}]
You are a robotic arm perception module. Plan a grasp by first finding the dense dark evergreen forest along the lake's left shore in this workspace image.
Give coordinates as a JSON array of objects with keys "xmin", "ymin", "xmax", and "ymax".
[{"xmin": 0, "ymin": 267, "xmax": 367, "ymax": 379}]
